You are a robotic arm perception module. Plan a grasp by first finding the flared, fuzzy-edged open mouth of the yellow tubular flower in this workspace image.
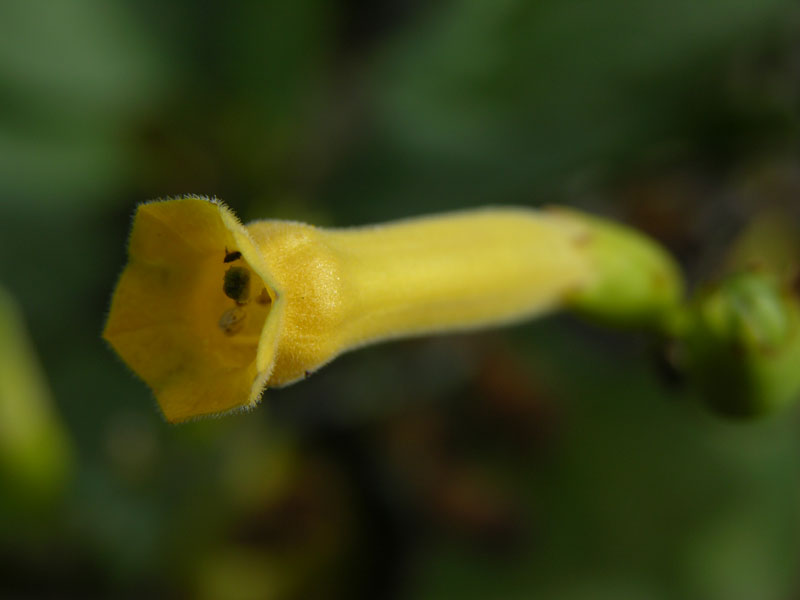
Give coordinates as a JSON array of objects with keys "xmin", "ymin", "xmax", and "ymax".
[{"xmin": 103, "ymin": 198, "xmax": 279, "ymax": 422}]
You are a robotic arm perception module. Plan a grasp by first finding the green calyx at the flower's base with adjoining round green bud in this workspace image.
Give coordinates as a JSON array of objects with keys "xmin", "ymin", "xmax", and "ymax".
[{"xmin": 565, "ymin": 211, "xmax": 800, "ymax": 417}]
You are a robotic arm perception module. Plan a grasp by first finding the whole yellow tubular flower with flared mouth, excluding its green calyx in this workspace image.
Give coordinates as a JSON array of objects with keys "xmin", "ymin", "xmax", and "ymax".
[{"xmin": 103, "ymin": 197, "xmax": 674, "ymax": 422}]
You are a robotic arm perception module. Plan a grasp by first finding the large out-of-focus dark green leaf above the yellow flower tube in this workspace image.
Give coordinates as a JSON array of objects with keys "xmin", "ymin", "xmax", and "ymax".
[{"xmin": 328, "ymin": 0, "xmax": 794, "ymax": 218}]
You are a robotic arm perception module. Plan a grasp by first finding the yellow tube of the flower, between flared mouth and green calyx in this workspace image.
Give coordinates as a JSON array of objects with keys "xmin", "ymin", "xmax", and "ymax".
[{"xmin": 247, "ymin": 209, "xmax": 591, "ymax": 386}]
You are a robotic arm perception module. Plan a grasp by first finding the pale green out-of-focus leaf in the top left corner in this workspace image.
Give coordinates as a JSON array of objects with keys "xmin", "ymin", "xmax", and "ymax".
[{"xmin": 0, "ymin": 0, "xmax": 166, "ymax": 210}]
